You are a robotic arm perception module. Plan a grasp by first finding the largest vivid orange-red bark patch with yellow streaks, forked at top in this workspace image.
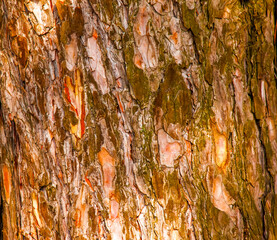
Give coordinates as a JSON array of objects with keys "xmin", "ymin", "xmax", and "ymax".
[{"xmin": 64, "ymin": 69, "xmax": 86, "ymax": 139}]
